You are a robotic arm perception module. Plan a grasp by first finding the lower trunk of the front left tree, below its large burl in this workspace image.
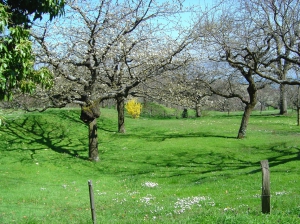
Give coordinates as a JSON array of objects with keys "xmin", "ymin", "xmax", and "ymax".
[{"xmin": 88, "ymin": 118, "xmax": 99, "ymax": 162}]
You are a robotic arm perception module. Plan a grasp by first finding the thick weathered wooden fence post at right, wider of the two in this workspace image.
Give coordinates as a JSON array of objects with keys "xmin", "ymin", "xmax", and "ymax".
[{"xmin": 260, "ymin": 160, "xmax": 271, "ymax": 214}]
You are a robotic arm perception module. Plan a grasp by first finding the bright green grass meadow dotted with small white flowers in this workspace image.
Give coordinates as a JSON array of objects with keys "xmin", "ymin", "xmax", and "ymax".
[{"xmin": 0, "ymin": 109, "xmax": 300, "ymax": 223}]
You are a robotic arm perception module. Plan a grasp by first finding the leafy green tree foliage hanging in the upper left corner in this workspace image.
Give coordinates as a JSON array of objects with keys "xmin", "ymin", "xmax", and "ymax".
[{"xmin": 0, "ymin": 0, "xmax": 65, "ymax": 100}]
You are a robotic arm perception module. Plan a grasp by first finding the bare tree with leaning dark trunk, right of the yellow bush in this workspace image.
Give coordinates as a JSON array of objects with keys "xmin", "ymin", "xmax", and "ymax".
[{"xmin": 193, "ymin": 0, "xmax": 265, "ymax": 138}]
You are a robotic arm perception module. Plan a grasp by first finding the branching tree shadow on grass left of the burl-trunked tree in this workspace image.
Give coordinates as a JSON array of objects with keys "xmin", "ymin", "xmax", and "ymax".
[{"xmin": 1, "ymin": 116, "xmax": 87, "ymax": 160}]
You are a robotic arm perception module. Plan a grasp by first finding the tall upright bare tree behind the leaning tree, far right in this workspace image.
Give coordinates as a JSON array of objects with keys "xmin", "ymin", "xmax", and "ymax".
[{"xmin": 243, "ymin": 0, "xmax": 299, "ymax": 115}]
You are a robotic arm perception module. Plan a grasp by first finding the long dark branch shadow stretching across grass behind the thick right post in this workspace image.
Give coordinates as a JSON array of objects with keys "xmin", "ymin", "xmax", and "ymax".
[{"xmin": 99, "ymin": 142, "xmax": 300, "ymax": 184}]
